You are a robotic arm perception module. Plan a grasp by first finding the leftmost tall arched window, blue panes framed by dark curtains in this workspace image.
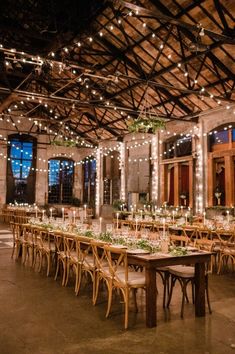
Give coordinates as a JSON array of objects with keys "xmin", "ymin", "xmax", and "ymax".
[{"xmin": 7, "ymin": 134, "xmax": 36, "ymax": 204}]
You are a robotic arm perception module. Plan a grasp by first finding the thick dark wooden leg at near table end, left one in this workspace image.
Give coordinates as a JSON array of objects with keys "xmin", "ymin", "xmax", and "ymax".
[{"xmin": 145, "ymin": 267, "xmax": 157, "ymax": 328}]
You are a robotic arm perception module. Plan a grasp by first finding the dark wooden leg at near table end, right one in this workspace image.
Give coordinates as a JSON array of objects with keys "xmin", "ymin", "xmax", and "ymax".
[{"xmin": 195, "ymin": 263, "xmax": 206, "ymax": 317}]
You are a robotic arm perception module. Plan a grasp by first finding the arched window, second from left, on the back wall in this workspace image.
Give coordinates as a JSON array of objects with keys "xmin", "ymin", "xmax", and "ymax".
[{"xmin": 48, "ymin": 157, "xmax": 74, "ymax": 204}]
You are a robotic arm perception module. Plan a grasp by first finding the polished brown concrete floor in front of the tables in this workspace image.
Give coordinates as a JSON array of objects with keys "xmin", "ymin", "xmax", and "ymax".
[{"xmin": 0, "ymin": 225, "xmax": 235, "ymax": 354}]
